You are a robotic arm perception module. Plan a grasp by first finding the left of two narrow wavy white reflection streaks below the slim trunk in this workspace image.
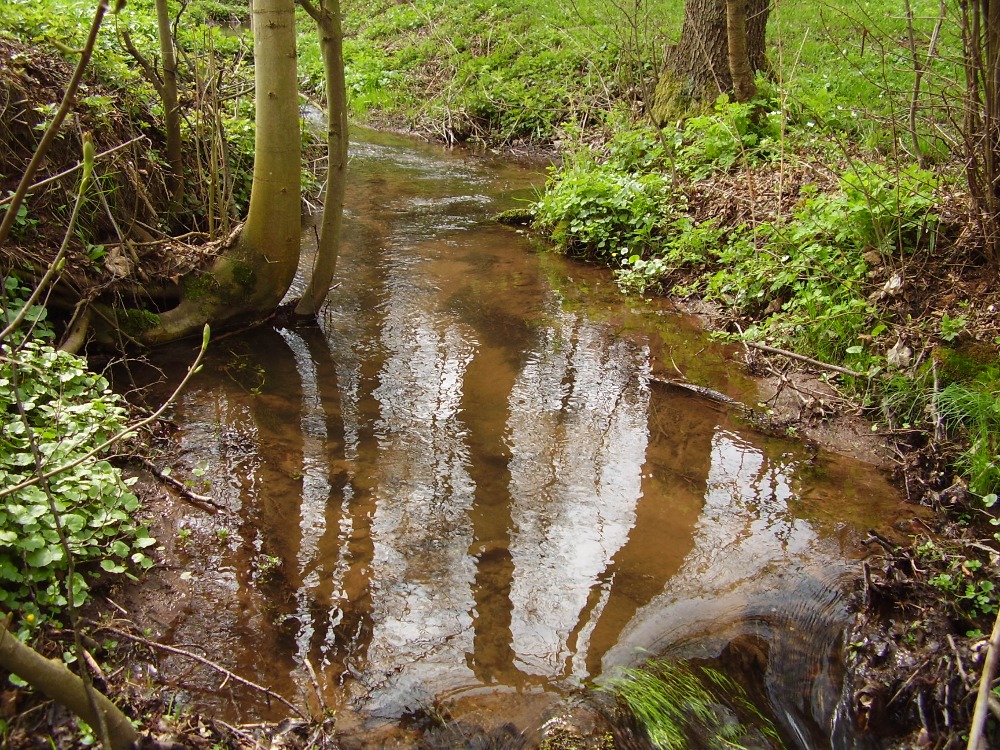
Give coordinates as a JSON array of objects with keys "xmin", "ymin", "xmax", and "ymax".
[{"xmin": 278, "ymin": 329, "xmax": 330, "ymax": 664}]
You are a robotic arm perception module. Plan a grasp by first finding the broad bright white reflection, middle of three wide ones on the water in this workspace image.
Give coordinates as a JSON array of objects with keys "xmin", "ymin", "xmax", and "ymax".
[{"xmin": 508, "ymin": 316, "xmax": 649, "ymax": 678}]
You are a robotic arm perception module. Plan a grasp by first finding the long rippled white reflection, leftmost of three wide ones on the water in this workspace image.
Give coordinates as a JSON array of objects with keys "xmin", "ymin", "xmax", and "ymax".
[{"xmin": 363, "ymin": 299, "xmax": 475, "ymax": 716}]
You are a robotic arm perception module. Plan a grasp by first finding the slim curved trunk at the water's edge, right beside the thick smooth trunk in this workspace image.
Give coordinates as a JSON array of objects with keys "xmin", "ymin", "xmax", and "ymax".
[{"xmin": 295, "ymin": 0, "xmax": 348, "ymax": 316}]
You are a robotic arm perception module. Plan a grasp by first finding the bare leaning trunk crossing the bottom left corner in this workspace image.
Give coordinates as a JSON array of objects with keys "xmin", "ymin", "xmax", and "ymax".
[{"xmin": 0, "ymin": 623, "xmax": 139, "ymax": 750}]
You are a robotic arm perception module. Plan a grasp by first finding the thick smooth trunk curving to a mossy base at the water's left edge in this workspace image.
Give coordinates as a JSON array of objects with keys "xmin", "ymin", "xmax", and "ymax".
[{"xmin": 135, "ymin": 0, "xmax": 301, "ymax": 344}]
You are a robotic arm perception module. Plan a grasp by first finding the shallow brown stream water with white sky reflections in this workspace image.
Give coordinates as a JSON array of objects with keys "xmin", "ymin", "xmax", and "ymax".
[{"xmin": 139, "ymin": 136, "xmax": 900, "ymax": 747}]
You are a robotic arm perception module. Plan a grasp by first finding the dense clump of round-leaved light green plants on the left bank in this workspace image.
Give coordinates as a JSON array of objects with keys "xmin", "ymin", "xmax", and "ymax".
[{"xmin": 0, "ymin": 278, "xmax": 154, "ymax": 638}]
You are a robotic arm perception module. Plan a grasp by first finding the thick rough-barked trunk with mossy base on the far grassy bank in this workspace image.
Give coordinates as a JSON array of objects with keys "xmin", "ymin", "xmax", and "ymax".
[{"xmin": 654, "ymin": 0, "xmax": 770, "ymax": 123}]
